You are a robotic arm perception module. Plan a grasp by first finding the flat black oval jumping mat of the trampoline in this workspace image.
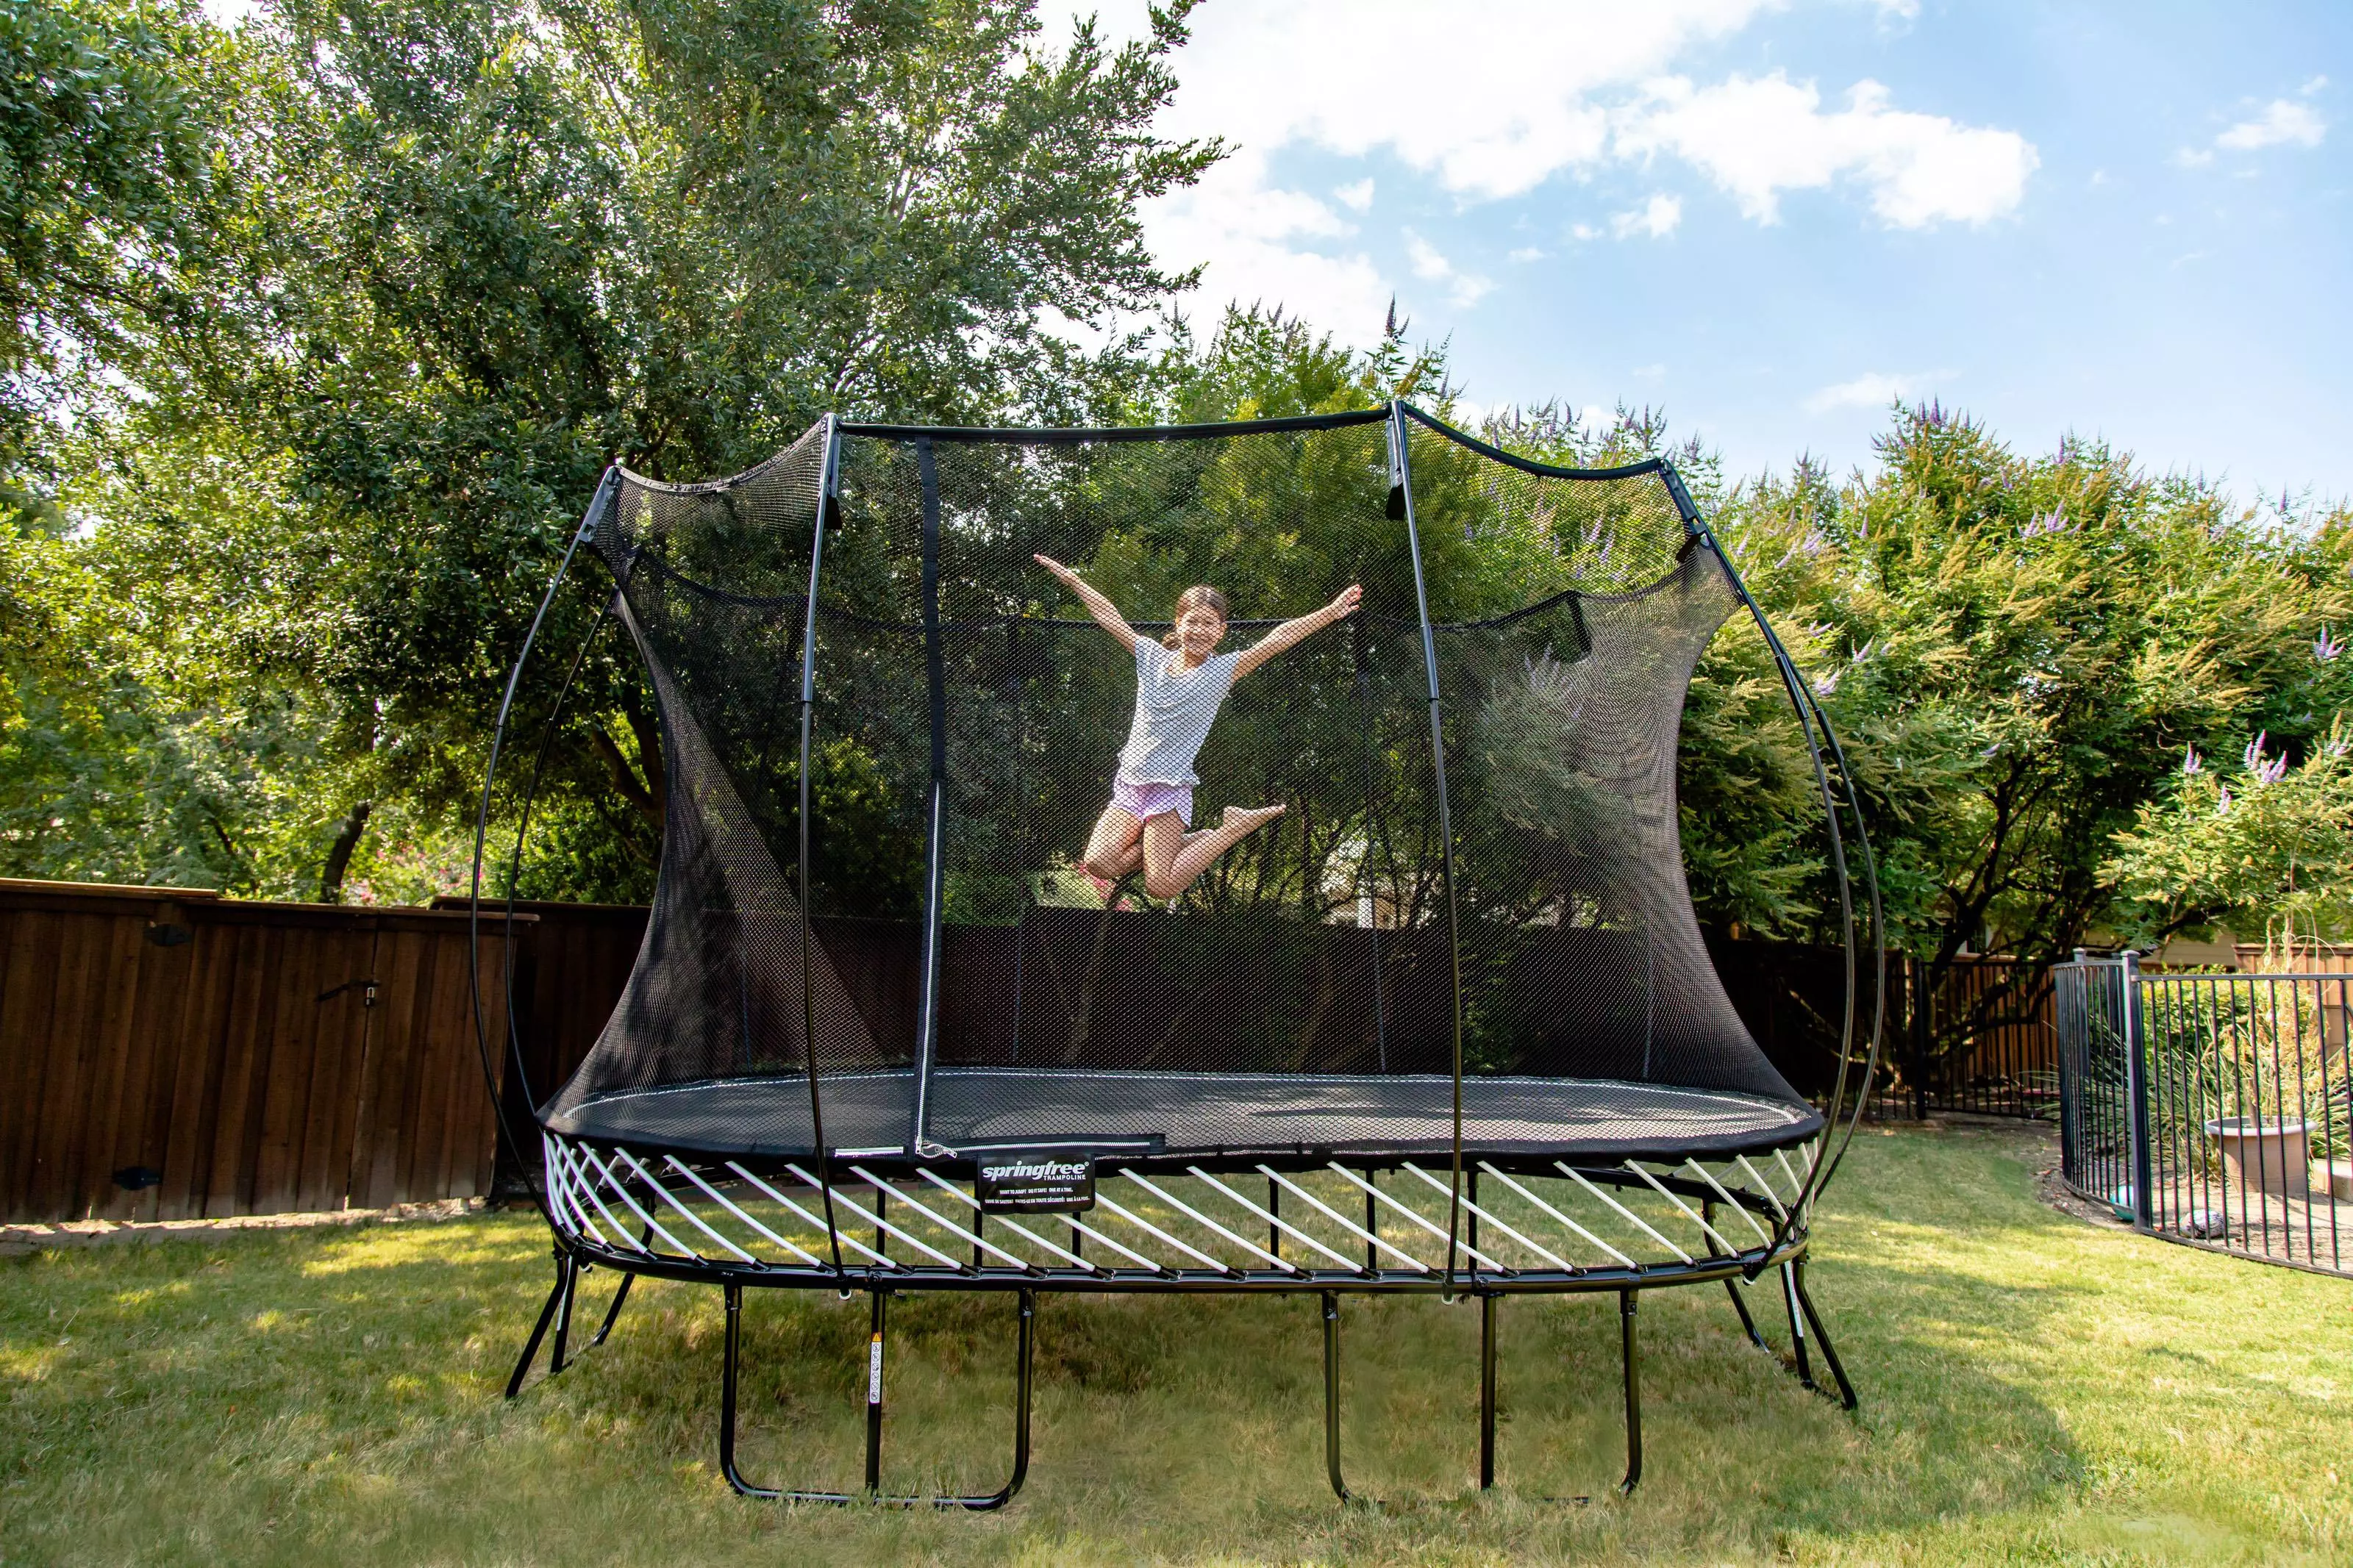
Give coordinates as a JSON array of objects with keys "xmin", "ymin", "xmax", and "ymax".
[{"xmin": 549, "ymin": 1067, "xmax": 1821, "ymax": 1161}]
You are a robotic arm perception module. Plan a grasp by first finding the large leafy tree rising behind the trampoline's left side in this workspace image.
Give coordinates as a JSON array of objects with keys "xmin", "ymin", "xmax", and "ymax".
[{"xmin": 31, "ymin": 0, "xmax": 1219, "ymax": 898}]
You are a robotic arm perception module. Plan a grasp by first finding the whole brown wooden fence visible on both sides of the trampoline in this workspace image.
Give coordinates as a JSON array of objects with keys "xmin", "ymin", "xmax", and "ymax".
[{"xmin": 0, "ymin": 879, "xmax": 2057, "ymax": 1222}]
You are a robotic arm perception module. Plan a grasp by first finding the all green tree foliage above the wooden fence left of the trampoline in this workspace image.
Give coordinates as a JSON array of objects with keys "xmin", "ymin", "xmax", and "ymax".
[{"xmin": 13, "ymin": 0, "xmax": 1219, "ymax": 898}]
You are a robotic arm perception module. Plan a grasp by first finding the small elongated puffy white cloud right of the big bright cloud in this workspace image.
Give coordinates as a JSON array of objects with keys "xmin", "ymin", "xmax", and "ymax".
[{"xmin": 1614, "ymin": 71, "xmax": 2043, "ymax": 228}]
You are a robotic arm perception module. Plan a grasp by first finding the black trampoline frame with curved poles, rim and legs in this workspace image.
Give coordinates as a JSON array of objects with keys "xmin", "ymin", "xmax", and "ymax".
[{"xmin": 468, "ymin": 400, "xmax": 1885, "ymax": 1509}]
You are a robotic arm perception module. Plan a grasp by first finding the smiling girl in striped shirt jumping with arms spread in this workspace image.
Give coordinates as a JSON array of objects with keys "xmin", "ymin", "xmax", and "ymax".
[{"xmin": 1038, "ymin": 555, "xmax": 1365, "ymax": 898}]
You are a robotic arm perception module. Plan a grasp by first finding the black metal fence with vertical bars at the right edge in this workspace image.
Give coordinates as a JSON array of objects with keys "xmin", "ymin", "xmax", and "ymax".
[{"xmin": 2052, "ymin": 954, "xmax": 2353, "ymax": 1274}]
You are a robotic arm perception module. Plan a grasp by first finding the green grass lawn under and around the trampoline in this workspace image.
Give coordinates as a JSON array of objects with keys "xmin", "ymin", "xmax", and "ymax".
[{"xmin": 0, "ymin": 1131, "xmax": 2353, "ymax": 1566}]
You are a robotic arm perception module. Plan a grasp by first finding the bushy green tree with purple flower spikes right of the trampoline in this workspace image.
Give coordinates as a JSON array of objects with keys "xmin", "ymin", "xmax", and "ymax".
[{"xmin": 1722, "ymin": 407, "xmax": 2349, "ymax": 966}]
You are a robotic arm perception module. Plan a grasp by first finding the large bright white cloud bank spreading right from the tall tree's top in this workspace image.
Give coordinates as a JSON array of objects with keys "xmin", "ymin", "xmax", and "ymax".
[{"xmin": 1038, "ymin": 0, "xmax": 2035, "ymax": 341}]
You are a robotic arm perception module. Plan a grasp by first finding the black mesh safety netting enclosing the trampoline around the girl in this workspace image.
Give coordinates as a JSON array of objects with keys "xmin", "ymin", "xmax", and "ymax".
[{"xmin": 546, "ymin": 412, "xmax": 1814, "ymax": 1154}]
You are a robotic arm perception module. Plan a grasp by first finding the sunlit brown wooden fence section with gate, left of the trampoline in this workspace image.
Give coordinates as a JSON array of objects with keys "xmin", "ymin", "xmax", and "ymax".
[{"xmin": 0, "ymin": 879, "xmax": 520, "ymax": 1222}]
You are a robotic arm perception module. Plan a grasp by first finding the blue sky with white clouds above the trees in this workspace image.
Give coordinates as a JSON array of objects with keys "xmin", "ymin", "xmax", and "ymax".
[{"xmin": 1047, "ymin": 0, "xmax": 2353, "ymax": 501}]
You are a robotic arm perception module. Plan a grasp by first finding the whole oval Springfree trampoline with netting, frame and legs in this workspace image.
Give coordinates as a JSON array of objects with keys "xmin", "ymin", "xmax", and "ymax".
[{"xmin": 475, "ymin": 402, "xmax": 1882, "ymax": 1509}]
